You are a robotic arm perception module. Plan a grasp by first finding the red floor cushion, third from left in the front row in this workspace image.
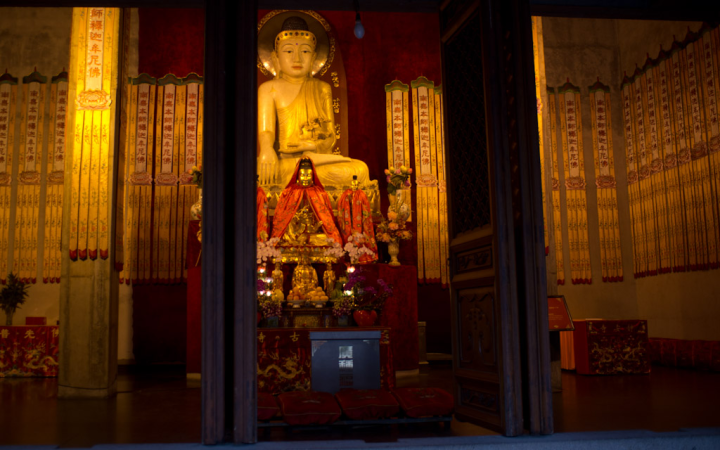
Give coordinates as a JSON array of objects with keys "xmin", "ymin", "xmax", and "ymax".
[{"xmin": 335, "ymin": 389, "xmax": 400, "ymax": 420}]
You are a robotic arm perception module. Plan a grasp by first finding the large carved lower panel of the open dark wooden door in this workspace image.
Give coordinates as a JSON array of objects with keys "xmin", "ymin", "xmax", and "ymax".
[{"xmin": 457, "ymin": 288, "xmax": 496, "ymax": 371}]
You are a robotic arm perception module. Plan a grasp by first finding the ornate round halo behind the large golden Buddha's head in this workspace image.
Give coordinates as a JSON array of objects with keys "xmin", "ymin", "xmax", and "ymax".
[{"xmin": 258, "ymin": 10, "xmax": 335, "ymax": 78}]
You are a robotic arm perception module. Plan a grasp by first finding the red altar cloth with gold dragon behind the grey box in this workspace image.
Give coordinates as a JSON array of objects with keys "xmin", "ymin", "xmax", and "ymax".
[{"xmin": 257, "ymin": 327, "xmax": 395, "ymax": 394}]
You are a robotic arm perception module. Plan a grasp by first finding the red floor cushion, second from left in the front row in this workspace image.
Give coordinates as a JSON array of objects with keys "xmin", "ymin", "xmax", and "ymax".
[{"xmin": 278, "ymin": 391, "xmax": 342, "ymax": 425}]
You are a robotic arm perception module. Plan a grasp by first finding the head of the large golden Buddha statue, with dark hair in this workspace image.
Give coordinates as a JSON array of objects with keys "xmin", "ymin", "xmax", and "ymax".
[{"xmin": 272, "ymin": 16, "xmax": 317, "ymax": 78}]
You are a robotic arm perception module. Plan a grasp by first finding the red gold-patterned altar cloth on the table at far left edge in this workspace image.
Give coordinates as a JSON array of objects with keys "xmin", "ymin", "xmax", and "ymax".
[{"xmin": 0, "ymin": 325, "xmax": 60, "ymax": 377}]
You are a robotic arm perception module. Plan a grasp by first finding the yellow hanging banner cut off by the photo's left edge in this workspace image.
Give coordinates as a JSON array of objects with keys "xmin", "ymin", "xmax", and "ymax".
[{"xmin": 0, "ymin": 72, "xmax": 18, "ymax": 284}]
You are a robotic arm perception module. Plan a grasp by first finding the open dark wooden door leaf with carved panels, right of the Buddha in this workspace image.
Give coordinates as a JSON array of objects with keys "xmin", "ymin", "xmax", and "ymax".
[{"xmin": 441, "ymin": 2, "xmax": 522, "ymax": 435}]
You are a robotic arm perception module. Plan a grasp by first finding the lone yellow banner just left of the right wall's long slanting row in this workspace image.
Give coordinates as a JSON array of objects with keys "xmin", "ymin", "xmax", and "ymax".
[{"xmin": 588, "ymin": 79, "xmax": 623, "ymax": 282}]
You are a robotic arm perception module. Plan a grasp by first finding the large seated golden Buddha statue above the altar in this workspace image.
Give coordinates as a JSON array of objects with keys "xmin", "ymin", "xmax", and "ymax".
[{"xmin": 258, "ymin": 16, "xmax": 369, "ymax": 186}]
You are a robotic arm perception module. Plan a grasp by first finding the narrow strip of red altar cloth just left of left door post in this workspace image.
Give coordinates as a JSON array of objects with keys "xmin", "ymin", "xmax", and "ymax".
[{"xmin": 185, "ymin": 220, "xmax": 202, "ymax": 373}]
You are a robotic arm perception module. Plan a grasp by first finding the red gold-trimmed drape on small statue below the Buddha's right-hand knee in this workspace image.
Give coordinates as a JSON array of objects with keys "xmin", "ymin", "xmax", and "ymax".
[{"xmin": 338, "ymin": 189, "xmax": 377, "ymax": 263}]
